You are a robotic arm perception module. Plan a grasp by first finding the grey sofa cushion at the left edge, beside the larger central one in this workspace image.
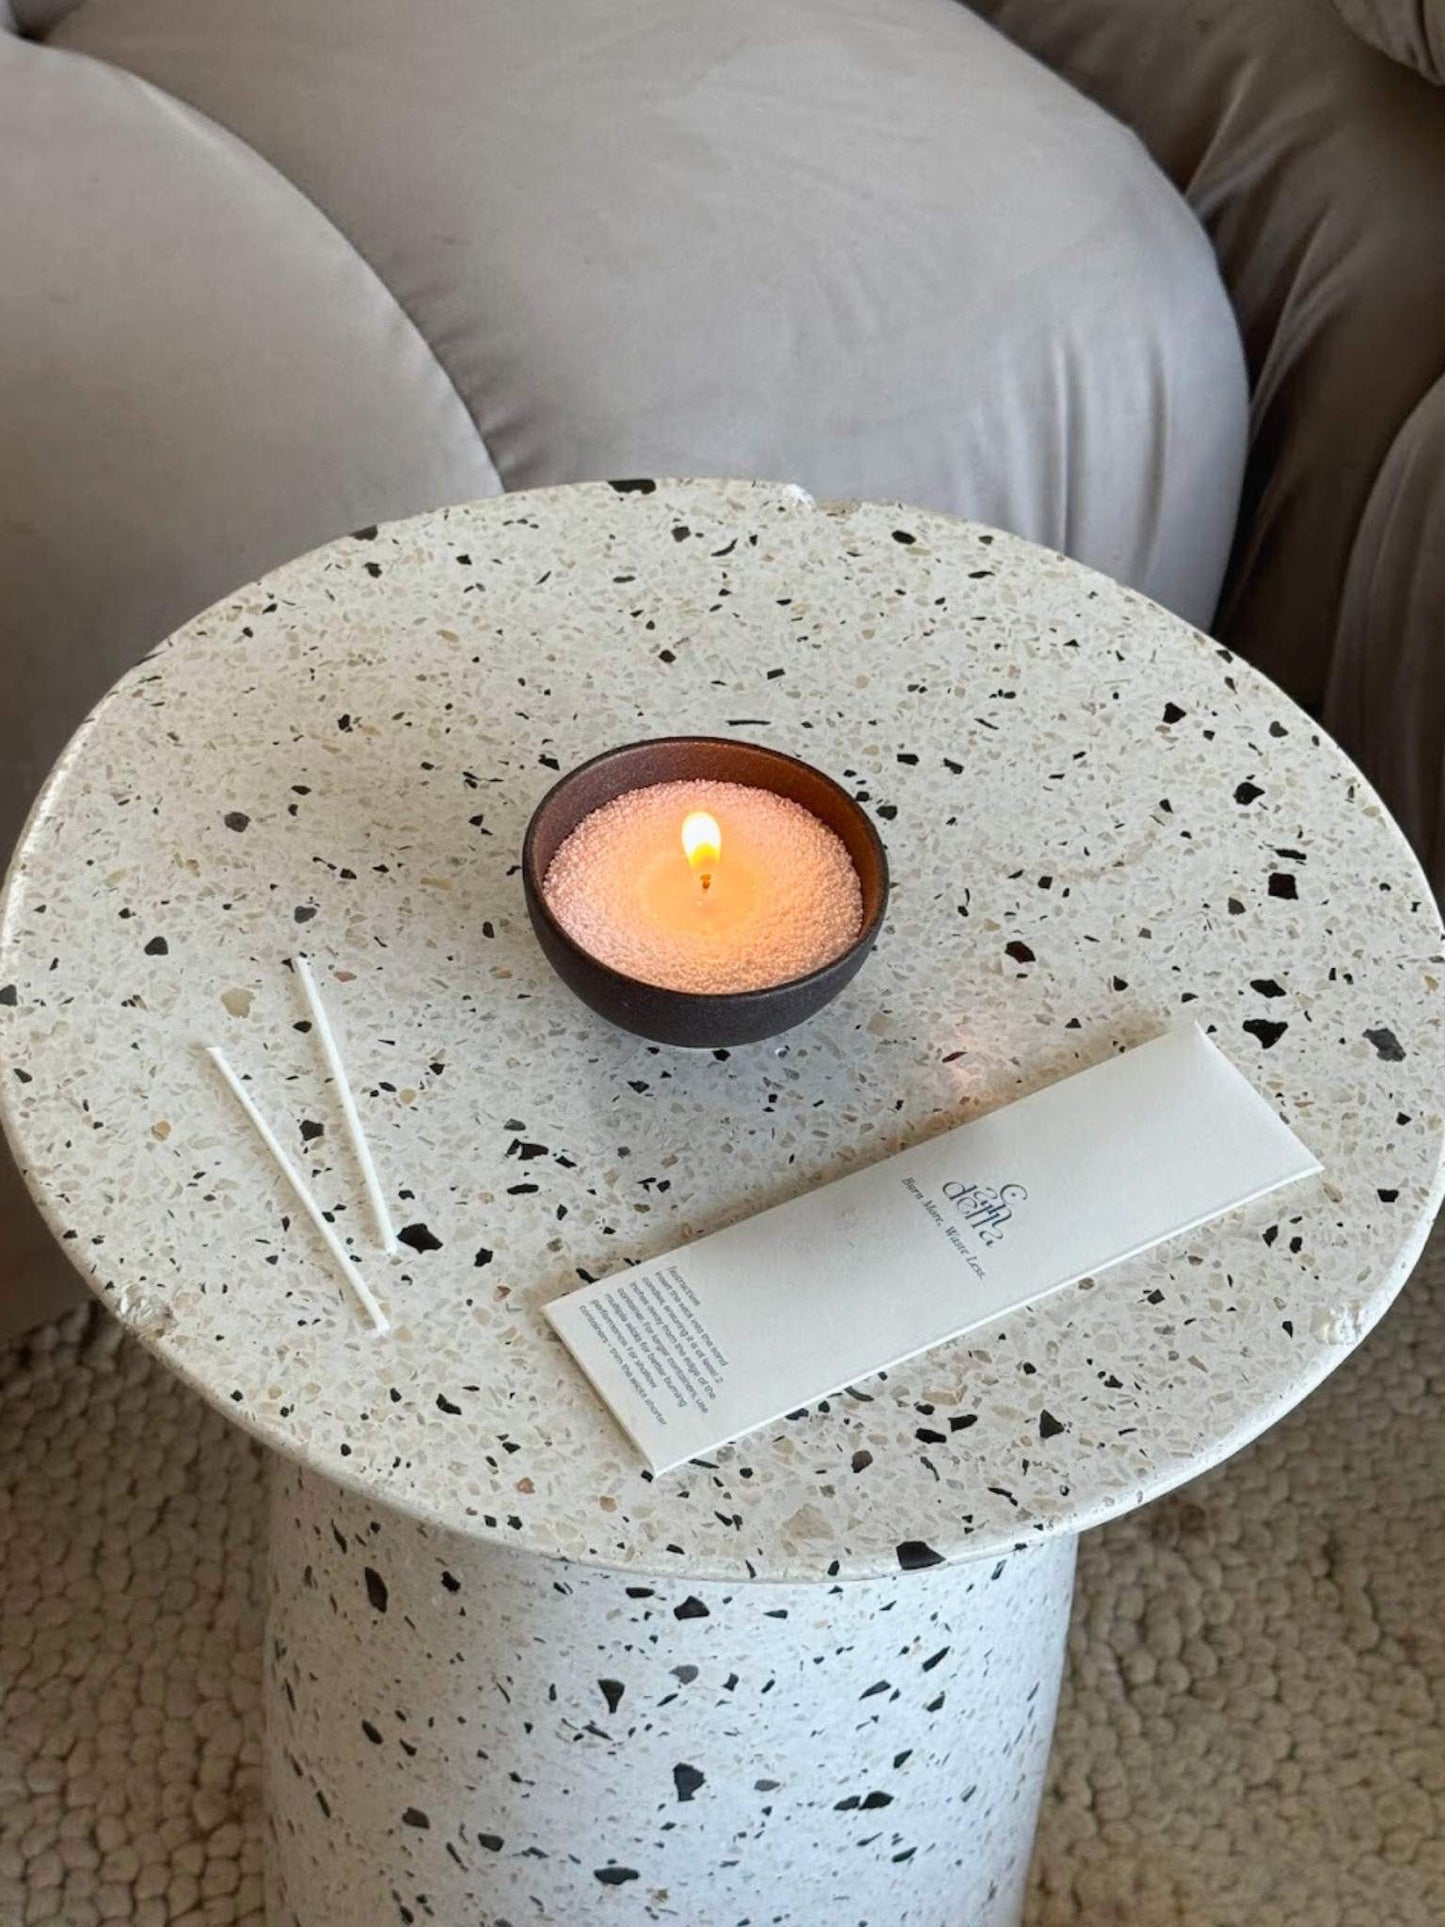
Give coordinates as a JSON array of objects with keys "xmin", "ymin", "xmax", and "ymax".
[{"xmin": 0, "ymin": 35, "xmax": 497, "ymax": 852}]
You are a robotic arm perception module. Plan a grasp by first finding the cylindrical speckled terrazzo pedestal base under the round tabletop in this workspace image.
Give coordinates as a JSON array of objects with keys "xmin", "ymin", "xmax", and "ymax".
[{"xmin": 266, "ymin": 1461, "xmax": 1075, "ymax": 1927}]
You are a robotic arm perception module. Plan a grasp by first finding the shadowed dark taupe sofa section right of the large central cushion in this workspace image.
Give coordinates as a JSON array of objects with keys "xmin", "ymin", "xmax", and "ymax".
[{"xmin": 975, "ymin": 0, "xmax": 1445, "ymax": 732}]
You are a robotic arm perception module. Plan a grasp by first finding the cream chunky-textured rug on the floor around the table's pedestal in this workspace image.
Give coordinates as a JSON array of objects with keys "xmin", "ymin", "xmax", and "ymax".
[{"xmin": 0, "ymin": 1235, "xmax": 1445, "ymax": 1927}]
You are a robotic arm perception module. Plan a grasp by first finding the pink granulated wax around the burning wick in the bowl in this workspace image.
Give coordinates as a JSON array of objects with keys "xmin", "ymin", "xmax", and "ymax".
[{"xmin": 541, "ymin": 779, "xmax": 863, "ymax": 992}]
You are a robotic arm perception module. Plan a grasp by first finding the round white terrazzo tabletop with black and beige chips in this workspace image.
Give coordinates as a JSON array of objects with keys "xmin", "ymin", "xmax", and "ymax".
[{"xmin": 0, "ymin": 482, "xmax": 1445, "ymax": 1578}]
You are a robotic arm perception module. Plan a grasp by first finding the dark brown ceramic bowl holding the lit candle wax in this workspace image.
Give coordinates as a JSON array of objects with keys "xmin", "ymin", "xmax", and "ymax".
[{"xmin": 522, "ymin": 736, "xmax": 888, "ymax": 1050}]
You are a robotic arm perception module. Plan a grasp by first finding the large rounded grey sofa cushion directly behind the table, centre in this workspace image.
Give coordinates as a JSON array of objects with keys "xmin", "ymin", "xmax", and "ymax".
[{"xmin": 56, "ymin": 0, "xmax": 1243, "ymax": 620}]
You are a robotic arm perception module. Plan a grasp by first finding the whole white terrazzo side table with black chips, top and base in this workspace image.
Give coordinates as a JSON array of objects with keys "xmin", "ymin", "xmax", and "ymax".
[{"xmin": 0, "ymin": 484, "xmax": 1445, "ymax": 1927}]
